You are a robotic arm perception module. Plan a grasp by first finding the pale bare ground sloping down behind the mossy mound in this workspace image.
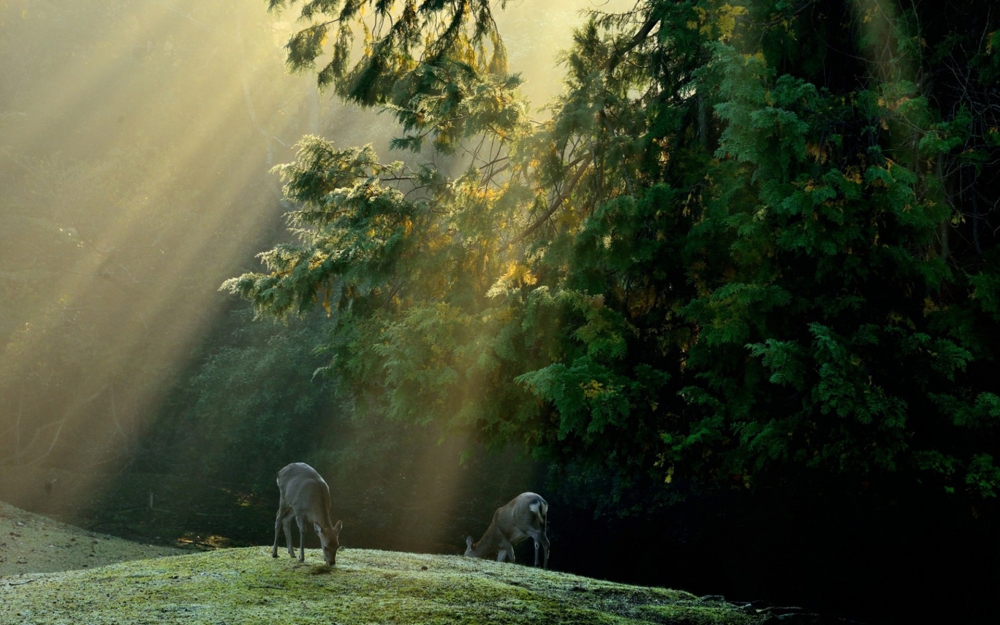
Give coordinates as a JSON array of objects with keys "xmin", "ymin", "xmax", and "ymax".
[{"xmin": 0, "ymin": 501, "xmax": 191, "ymax": 576}]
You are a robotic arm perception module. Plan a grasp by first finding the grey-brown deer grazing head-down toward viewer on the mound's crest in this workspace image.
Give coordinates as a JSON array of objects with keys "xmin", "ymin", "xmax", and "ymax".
[{"xmin": 271, "ymin": 462, "xmax": 344, "ymax": 566}]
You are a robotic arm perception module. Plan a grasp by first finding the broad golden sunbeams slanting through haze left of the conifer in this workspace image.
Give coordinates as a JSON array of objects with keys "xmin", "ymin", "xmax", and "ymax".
[{"xmin": 0, "ymin": 2, "xmax": 336, "ymax": 508}]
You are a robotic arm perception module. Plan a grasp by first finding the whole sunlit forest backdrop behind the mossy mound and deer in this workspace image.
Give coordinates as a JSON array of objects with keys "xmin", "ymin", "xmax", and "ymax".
[{"xmin": 0, "ymin": 0, "xmax": 1000, "ymax": 624}]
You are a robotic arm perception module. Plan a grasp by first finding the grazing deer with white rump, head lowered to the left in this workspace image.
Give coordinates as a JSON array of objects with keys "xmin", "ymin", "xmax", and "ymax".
[{"xmin": 465, "ymin": 493, "xmax": 549, "ymax": 569}]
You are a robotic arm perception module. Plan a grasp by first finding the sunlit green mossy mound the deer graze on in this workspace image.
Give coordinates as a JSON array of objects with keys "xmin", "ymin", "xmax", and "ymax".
[{"xmin": 0, "ymin": 547, "xmax": 761, "ymax": 625}]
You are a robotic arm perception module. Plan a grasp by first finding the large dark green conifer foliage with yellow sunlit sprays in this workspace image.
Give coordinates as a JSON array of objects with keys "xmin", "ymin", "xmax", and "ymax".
[{"xmin": 224, "ymin": 0, "xmax": 1000, "ymax": 500}]
